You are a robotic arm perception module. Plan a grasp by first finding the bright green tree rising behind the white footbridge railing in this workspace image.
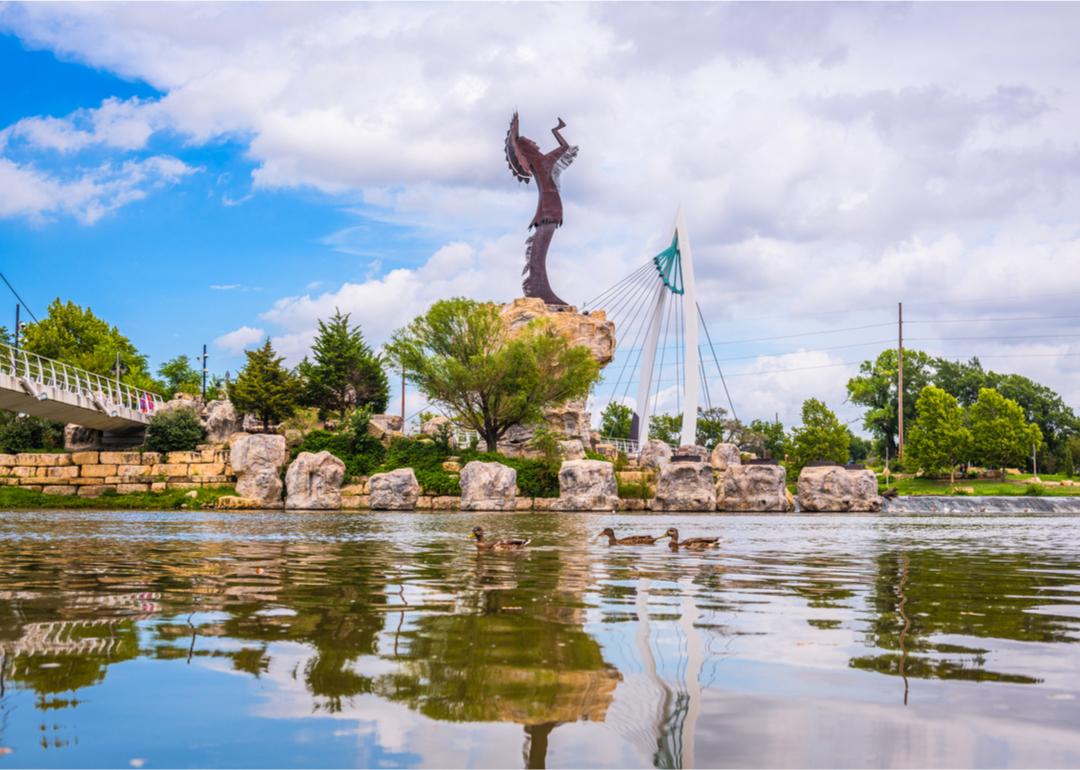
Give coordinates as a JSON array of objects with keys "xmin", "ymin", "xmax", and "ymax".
[{"xmin": 23, "ymin": 298, "xmax": 160, "ymax": 390}]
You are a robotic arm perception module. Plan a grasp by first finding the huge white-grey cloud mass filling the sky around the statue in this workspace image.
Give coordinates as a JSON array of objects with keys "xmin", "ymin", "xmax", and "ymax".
[{"xmin": 0, "ymin": 3, "xmax": 1080, "ymax": 418}]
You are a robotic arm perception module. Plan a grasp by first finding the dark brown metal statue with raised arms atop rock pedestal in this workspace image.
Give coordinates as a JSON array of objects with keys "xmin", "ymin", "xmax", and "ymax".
[{"xmin": 505, "ymin": 112, "xmax": 578, "ymax": 305}]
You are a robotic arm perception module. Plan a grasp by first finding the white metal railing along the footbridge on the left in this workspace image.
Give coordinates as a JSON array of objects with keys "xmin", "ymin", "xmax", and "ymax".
[{"xmin": 0, "ymin": 342, "xmax": 164, "ymax": 417}]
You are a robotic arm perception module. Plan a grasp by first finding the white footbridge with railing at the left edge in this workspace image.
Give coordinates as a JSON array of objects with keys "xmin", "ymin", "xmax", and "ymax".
[{"xmin": 0, "ymin": 343, "xmax": 164, "ymax": 431}]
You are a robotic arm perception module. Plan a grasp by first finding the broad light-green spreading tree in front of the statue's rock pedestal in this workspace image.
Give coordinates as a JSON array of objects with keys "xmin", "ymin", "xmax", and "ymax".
[{"xmin": 387, "ymin": 297, "xmax": 599, "ymax": 451}]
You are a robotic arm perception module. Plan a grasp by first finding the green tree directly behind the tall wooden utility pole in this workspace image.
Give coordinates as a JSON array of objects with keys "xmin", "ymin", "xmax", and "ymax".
[{"xmin": 848, "ymin": 349, "xmax": 934, "ymax": 457}]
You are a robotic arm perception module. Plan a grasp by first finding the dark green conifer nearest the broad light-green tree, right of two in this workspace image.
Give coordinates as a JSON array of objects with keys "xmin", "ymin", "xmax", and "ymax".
[{"xmin": 299, "ymin": 310, "xmax": 390, "ymax": 420}]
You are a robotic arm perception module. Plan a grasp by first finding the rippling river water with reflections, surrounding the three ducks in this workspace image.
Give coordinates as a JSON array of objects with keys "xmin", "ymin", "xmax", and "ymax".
[{"xmin": 0, "ymin": 512, "xmax": 1080, "ymax": 768}]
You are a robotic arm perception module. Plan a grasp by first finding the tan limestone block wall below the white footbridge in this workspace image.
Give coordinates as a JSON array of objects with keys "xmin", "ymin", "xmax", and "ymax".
[{"xmin": 0, "ymin": 447, "xmax": 237, "ymax": 497}]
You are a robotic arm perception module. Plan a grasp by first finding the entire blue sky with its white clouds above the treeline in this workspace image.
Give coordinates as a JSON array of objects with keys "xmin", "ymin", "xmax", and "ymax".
[{"xmin": 0, "ymin": 3, "xmax": 1080, "ymax": 424}]
